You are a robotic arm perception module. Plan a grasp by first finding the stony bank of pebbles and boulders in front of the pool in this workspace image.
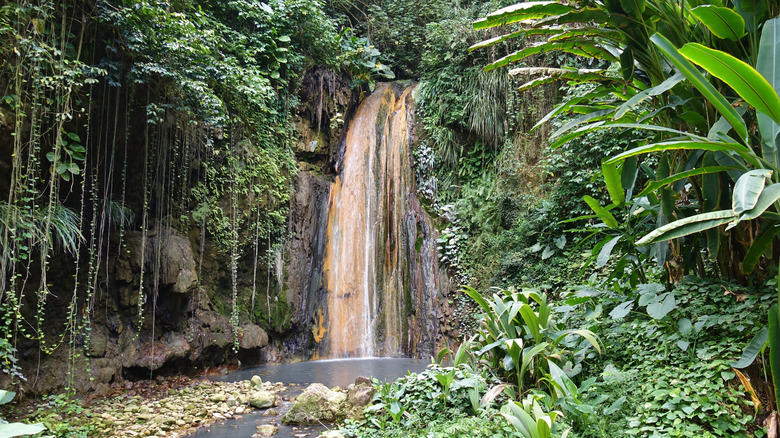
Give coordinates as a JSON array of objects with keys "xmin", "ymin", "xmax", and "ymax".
[{"xmin": 16, "ymin": 376, "xmax": 375, "ymax": 438}]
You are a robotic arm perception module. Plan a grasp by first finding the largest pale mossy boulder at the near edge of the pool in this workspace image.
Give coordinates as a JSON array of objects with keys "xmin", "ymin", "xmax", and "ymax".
[{"xmin": 282, "ymin": 383, "xmax": 347, "ymax": 424}]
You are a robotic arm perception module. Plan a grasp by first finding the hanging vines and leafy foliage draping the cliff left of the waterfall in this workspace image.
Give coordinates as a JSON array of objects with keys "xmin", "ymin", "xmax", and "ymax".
[{"xmin": 0, "ymin": 0, "xmax": 348, "ymax": 384}]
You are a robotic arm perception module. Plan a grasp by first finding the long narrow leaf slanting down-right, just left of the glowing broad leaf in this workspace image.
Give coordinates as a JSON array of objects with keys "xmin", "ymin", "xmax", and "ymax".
[{"xmin": 650, "ymin": 33, "xmax": 748, "ymax": 143}]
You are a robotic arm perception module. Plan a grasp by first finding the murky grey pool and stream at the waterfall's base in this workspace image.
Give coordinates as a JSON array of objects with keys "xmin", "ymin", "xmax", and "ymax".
[{"xmin": 192, "ymin": 358, "xmax": 430, "ymax": 438}]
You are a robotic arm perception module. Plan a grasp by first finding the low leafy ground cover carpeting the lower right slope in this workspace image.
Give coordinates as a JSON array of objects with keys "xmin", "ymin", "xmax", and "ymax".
[{"xmin": 571, "ymin": 278, "xmax": 773, "ymax": 436}]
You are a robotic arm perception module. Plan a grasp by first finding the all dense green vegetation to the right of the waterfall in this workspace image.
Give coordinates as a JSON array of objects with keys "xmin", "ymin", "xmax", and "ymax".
[{"xmin": 328, "ymin": 0, "xmax": 780, "ymax": 437}]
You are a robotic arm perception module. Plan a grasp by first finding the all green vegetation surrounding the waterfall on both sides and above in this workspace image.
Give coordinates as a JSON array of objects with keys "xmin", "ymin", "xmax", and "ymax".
[{"xmin": 0, "ymin": 0, "xmax": 780, "ymax": 438}]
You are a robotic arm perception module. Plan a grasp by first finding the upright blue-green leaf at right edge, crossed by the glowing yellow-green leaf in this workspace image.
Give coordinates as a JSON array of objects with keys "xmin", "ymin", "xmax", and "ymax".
[{"xmin": 756, "ymin": 17, "xmax": 780, "ymax": 167}]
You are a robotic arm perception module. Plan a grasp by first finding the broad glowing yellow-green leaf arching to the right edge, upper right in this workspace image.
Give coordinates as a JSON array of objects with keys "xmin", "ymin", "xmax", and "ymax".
[{"xmin": 680, "ymin": 43, "xmax": 780, "ymax": 123}]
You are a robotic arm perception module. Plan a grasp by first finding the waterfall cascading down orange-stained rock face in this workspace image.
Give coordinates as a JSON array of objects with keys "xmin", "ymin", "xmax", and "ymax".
[{"xmin": 316, "ymin": 83, "xmax": 438, "ymax": 358}]
